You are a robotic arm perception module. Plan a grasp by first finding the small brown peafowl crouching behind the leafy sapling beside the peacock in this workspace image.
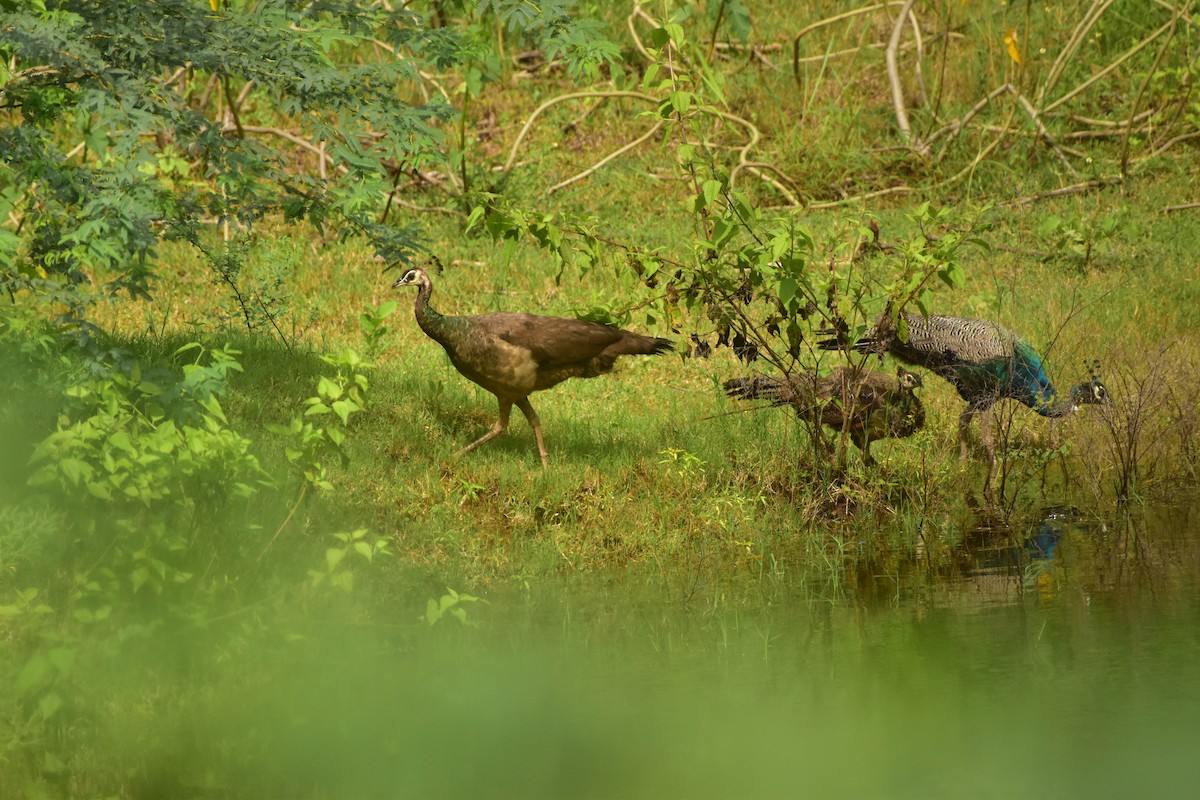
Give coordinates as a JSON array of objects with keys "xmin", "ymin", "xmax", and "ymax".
[{"xmin": 725, "ymin": 367, "xmax": 925, "ymax": 464}]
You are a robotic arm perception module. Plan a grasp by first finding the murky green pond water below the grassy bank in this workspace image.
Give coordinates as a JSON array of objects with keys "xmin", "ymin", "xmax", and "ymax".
[{"xmin": 196, "ymin": 510, "xmax": 1200, "ymax": 798}]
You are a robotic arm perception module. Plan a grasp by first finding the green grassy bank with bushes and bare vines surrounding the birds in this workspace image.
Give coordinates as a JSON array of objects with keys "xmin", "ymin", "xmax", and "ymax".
[{"xmin": 0, "ymin": 1, "xmax": 1200, "ymax": 796}]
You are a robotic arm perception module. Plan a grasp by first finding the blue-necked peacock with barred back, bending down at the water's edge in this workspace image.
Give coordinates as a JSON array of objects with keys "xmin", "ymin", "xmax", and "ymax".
[{"xmin": 820, "ymin": 313, "xmax": 1109, "ymax": 486}]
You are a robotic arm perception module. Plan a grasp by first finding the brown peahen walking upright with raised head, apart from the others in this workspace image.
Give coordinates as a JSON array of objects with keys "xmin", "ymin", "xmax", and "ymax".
[{"xmin": 392, "ymin": 267, "xmax": 673, "ymax": 467}]
